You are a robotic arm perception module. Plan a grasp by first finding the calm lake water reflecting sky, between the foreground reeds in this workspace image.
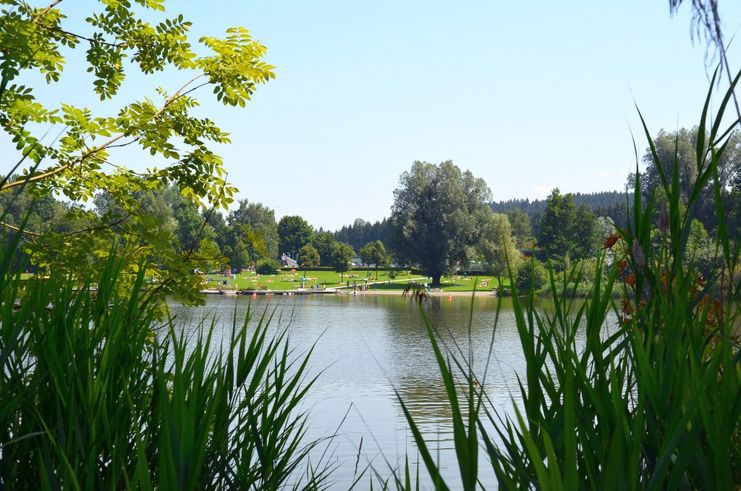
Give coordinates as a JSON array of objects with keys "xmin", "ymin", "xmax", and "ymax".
[{"xmin": 171, "ymin": 295, "xmax": 584, "ymax": 489}]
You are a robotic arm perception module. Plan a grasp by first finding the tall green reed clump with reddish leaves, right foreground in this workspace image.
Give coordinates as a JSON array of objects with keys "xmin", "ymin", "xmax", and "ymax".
[{"xmin": 391, "ymin": 74, "xmax": 741, "ymax": 490}]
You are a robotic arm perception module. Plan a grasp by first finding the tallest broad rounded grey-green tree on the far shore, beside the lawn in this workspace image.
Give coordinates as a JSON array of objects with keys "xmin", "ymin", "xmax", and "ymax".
[{"xmin": 391, "ymin": 161, "xmax": 491, "ymax": 286}]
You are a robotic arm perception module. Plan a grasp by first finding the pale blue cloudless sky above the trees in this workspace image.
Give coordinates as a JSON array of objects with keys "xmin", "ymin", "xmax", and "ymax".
[{"xmin": 5, "ymin": 0, "xmax": 741, "ymax": 229}]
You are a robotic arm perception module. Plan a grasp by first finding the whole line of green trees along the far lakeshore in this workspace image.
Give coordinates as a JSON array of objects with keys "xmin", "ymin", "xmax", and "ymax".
[{"xmin": 0, "ymin": 125, "xmax": 741, "ymax": 296}]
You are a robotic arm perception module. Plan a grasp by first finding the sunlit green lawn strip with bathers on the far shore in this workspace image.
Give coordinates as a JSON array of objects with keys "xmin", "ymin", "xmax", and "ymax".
[{"xmin": 203, "ymin": 270, "xmax": 506, "ymax": 292}]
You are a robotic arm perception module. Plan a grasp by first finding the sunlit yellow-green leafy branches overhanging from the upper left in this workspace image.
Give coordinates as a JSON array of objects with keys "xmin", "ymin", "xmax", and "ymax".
[{"xmin": 0, "ymin": 0, "xmax": 274, "ymax": 304}]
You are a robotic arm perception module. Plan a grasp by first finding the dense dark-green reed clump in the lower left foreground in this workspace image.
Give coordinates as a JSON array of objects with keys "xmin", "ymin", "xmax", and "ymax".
[{"xmin": 0, "ymin": 242, "xmax": 329, "ymax": 489}]
